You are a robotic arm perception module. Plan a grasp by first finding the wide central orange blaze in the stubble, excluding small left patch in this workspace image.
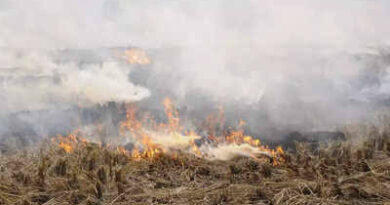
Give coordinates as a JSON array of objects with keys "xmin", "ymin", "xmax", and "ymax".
[{"xmin": 121, "ymin": 98, "xmax": 283, "ymax": 165}]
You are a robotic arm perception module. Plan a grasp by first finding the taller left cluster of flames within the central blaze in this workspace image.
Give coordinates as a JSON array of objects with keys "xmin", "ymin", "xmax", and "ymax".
[{"xmin": 120, "ymin": 98, "xmax": 200, "ymax": 160}]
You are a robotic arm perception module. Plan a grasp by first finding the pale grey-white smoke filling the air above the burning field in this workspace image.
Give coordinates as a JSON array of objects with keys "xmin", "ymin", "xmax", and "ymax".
[{"xmin": 0, "ymin": 0, "xmax": 390, "ymax": 144}]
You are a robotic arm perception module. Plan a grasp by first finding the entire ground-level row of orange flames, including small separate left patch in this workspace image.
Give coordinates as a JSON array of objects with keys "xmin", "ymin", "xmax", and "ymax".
[{"xmin": 54, "ymin": 98, "xmax": 284, "ymax": 165}]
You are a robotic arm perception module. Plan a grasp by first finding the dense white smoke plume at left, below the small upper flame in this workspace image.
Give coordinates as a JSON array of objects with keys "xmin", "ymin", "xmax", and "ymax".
[{"xmin": 0, "ymin": 50, "xmax": 149, "ymax": 112}]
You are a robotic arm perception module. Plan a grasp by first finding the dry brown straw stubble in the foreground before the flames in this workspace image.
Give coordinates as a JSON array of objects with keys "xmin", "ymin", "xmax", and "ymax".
[{"xmin": 0, "ymin": 127, "xmax": 390, "ymax": 205}]
